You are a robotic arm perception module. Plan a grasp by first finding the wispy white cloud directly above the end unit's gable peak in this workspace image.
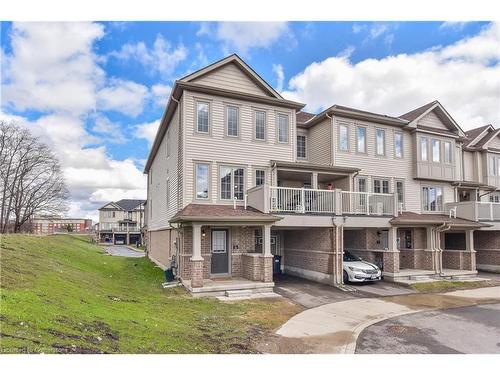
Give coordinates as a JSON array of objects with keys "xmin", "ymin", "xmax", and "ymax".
[{"xmin": 215, "ymin": 22, "xmax": 292, "ymax": 55}]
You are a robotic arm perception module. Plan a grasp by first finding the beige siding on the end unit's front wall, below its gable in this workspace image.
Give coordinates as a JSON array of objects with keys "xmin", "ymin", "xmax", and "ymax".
[{"xmin": 182, "ymin": 91, "xmax": 296, "ymax": 205}]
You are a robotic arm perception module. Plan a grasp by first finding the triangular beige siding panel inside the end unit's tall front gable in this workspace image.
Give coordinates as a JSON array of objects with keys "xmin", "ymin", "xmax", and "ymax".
[{"xmin": 192, "ymin": 64, "xmax": 270, "ymax": 96}]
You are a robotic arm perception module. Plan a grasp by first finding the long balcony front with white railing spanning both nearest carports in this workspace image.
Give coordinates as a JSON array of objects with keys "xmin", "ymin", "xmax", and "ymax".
[{"xmin": 248, "ymin": 185, "xmax": 397, "ymax": 216}]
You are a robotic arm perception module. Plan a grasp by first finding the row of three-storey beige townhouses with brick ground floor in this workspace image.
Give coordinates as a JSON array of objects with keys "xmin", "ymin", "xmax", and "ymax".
[{"xmin": 144, "ymin": 55, "xmax": 500, "ymax": 293}]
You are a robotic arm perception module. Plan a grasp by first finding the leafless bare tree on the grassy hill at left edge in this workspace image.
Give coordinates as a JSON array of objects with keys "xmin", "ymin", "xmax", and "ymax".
[{"xmin": 0, "ymin": 121, "xmax": 68, "ymax": 233}]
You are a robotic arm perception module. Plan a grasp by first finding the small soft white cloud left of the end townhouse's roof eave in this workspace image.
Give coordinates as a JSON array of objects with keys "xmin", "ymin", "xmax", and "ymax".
[{"xmin": 97, "ymin": 78, "xmax": 149, "ymax": 117}]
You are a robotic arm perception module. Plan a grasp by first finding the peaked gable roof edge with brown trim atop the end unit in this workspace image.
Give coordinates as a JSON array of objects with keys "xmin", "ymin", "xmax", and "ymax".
[{"xmin": 179, "ymin": 53, "xmax": 283, "ymax": 99}]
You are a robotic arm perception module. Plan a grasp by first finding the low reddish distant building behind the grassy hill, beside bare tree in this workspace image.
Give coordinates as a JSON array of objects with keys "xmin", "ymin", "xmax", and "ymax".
[{"xmin": 31, "ymin": 216, "xmax": 92, "ymax": 235}]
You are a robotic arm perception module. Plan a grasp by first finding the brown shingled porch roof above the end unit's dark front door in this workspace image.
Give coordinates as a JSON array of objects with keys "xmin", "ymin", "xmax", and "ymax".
[{"xmin": 170, "ymin": 203, "xmax": 281, "ymax": 223}]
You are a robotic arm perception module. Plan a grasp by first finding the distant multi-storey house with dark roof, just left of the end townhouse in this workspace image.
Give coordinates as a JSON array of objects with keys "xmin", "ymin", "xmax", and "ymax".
[{"xmin": 97, "ymin": 199, "xmax": 145, "ymax": 245}]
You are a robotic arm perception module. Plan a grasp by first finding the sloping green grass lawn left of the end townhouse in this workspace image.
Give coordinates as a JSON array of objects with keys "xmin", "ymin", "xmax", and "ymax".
[{"xmin": 0, "ymin": 235, "xmax": 301, "ymax": 353}]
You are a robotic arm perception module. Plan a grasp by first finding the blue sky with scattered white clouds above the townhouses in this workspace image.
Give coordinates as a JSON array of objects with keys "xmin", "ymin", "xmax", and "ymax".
[{"xmin": 0, "ymin": 22, "xmax": 500, "ymax": 217}]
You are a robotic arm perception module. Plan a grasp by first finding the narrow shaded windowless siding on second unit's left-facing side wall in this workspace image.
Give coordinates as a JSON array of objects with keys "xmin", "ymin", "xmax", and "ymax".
[{"xmin": 308, "ymin": 118, "xmax": 332, "ymax": 165}]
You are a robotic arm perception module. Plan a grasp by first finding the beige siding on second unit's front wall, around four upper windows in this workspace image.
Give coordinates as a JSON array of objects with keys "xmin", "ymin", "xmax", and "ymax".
[{"xmin": 333, "ymin": 116, "xmax": 421, "ymax": 212}]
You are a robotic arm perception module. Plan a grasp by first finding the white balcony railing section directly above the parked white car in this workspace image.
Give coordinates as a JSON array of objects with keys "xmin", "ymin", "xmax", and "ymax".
[{"xmin": 342, "ymin": 191, "xmax": 395, "ymax": 215}]
